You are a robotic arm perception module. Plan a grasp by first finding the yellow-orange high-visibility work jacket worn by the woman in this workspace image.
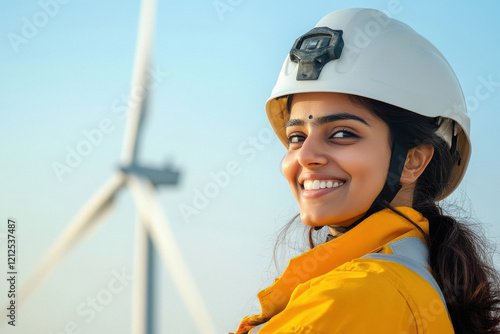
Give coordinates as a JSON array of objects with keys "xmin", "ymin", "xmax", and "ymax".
[{"xmin": 232, "ymin": 207, "xmax": 454, "ymax": 334}]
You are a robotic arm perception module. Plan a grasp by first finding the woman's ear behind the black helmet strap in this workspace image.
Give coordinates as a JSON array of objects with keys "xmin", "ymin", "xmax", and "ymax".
[{"xmin": 400, "ymin": 144, "xmax": 434, "ymax": 184}]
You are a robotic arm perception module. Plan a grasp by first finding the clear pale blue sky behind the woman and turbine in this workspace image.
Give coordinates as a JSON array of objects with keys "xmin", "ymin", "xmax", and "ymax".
[{"xmin": 0, "ymin": 0, "xmax": 500, "ymax": 334}]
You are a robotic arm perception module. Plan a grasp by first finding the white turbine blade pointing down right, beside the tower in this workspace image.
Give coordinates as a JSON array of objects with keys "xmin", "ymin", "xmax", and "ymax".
[{"xmin": 128, "ymin": 176, "xmax": 216, "ymax": 334}]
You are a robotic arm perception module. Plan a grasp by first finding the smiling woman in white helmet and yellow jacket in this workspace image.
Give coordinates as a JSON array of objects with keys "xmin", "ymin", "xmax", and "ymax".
[{"xmin": 230, "ymin": 9, "xmax": 500, "ymax": 334}]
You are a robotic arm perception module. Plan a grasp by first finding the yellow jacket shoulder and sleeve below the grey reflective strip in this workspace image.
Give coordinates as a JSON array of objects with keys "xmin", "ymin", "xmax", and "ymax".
[{"xmin": 259, "ymin": 258, "xmax": 453, "ymax": 334}]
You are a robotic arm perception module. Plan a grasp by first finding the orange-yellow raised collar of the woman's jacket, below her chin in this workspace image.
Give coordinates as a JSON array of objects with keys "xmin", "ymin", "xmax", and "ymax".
[{"xmin": 237, "ymin": 207, "xmax": 429, "ymax": 333}]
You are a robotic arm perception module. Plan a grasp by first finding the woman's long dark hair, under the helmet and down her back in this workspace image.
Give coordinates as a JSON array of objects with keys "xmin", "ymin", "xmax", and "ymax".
[{"xmin": 288, "ymin": 95, "xmax": 500, "ymax": 334}]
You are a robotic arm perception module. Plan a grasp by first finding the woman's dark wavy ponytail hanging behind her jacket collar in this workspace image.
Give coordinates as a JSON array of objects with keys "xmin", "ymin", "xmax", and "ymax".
[{"xmin": 414, "ymin": 202, "xmax": 500, "ymax": 334}]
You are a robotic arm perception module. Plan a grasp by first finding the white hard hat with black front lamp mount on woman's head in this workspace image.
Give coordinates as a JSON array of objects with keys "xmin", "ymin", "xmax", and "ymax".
[{"xmin": 266, "ymin": 8, "xmax": 471, "ymax": 200}]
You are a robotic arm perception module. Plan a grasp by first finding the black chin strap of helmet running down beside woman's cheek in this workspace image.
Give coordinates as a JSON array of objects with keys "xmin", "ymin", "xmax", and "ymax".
[{"xmin": 324, "ymin": 142, "xmax": 409, "ymax": 241}]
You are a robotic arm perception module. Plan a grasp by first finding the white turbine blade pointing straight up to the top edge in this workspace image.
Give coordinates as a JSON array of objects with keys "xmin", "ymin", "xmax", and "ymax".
[{"xmin": 121, "ymin": 0, "xmax": 156, "ymax": 166}]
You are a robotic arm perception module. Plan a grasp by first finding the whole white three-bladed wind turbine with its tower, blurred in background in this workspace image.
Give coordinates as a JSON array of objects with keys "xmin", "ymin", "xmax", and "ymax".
[{"xmin": 20, "ymin": 0, "xmax": 216, "ymax": 334}]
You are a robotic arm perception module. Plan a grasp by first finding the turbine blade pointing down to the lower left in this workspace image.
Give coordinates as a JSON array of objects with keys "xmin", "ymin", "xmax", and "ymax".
[{"xmin": 19, "ymin": 173, "xmax": 125, "ymax": 304}]
